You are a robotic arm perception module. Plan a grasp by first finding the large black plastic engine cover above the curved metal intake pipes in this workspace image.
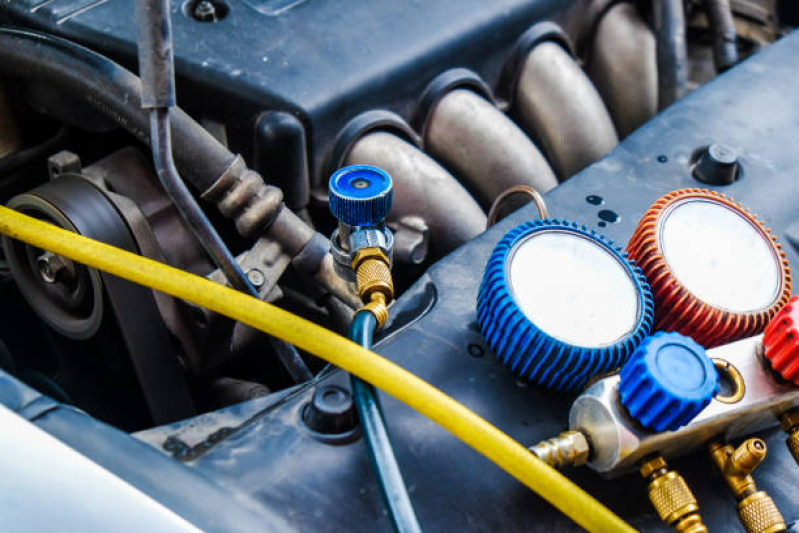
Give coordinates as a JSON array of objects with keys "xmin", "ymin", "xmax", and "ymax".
[{"xmin": 0, "ymin": 0, "xmax": 587, "ymax": 197}]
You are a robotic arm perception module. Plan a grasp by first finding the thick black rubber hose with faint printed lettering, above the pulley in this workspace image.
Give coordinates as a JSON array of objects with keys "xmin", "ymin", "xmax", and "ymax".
[{"xmin": 0, "ymin": 28, "xmax": 235, "ymax": 192}]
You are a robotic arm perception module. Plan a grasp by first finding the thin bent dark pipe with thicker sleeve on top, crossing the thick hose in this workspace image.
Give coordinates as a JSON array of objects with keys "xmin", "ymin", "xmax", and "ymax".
[{"xmin": 136, "ymin": 0, "xmax": 313, "ymax": 382}]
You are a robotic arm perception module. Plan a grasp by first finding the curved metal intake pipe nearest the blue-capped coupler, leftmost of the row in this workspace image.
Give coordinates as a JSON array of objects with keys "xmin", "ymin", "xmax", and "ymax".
[{"xmin": 345, "ymin": 131, "xmax": 486, "ymax": 257}]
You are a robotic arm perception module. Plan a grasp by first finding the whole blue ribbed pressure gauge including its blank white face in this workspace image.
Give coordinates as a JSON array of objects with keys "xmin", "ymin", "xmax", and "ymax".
[{"xmin": 477, "ymin": 220, "xmax": 654, "ymax": 391}]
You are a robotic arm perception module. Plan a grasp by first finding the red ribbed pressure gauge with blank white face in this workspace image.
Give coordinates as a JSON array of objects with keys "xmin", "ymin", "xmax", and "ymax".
[{"xmin": 627, "ymin": 189, "xmax": 791, "ymax": 348}]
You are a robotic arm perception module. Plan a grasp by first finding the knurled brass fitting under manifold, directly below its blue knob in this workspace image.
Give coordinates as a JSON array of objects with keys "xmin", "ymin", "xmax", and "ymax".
[{"xmin": 640, "ymin": 456, "xmax": 707, "ymax": 533}]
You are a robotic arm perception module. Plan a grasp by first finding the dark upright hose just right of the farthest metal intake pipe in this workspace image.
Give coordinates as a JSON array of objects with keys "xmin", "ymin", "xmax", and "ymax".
[{"xmin": 654, "ymin": 0, "xmax": 688, "ymax": 110}]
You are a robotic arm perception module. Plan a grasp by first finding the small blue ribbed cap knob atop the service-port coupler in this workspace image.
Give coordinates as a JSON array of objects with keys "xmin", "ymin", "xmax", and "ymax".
[{"xmin": 328, "ymin": 165, "xmax": 393, "ymax": 226}]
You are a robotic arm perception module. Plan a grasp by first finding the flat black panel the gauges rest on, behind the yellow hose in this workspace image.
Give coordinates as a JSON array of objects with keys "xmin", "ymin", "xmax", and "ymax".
[{"xmin": 128, "ymin": 28, "xmax": 799, "ymax": 532}]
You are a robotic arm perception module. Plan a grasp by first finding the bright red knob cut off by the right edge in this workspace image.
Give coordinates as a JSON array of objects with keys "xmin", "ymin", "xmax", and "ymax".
[{"xmin": 763, "ymin": 296, "xmax": 799, "ymax": 386}]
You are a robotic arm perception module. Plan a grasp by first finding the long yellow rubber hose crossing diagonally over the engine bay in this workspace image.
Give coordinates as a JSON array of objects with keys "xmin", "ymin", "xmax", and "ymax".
[{"xmin": 0, "ymin": 207, "xmax": 635, "ymax": 532}]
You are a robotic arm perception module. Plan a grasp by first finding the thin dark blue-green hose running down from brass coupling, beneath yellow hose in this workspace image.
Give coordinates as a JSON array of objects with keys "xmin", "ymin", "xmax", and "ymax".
[{"xmin": 349, "ymin": 311, "xmax": 422, "ymax": 533}]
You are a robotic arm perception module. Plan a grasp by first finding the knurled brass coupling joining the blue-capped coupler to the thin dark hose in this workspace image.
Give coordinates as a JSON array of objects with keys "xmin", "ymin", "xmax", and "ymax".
[{"xmin": 352, "ymin": 248, "xmax": 394, "ymax": 327}]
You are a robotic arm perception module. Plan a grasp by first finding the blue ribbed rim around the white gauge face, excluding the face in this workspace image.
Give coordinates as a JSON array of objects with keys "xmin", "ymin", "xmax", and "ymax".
[{"xmin": 477, "ymin": 220, "xmax": 654, "ymax": 391}]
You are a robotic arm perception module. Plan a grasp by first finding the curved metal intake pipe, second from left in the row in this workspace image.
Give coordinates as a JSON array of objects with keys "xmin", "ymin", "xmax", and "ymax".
[{"xmin": 425, "ymin": 89, "xmax": 558, "ymax": 208}]
